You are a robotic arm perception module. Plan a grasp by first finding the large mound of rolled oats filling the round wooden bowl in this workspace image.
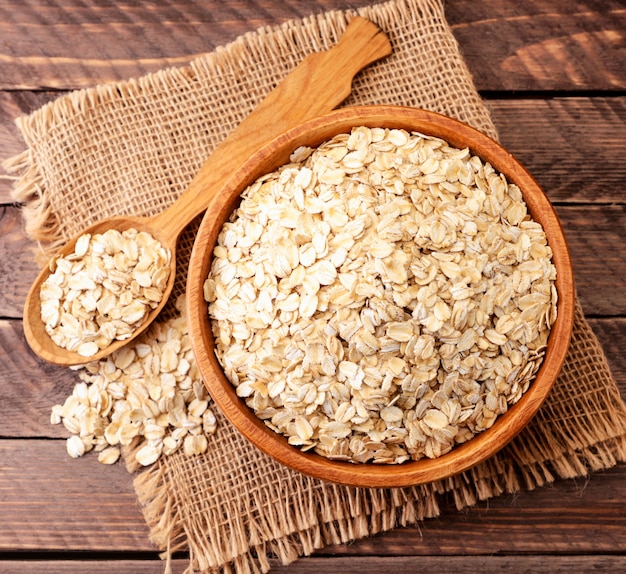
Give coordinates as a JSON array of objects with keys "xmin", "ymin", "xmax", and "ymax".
[{"xmin": 204, "ymin": 127, "xmax": 557, "ymax": 463}]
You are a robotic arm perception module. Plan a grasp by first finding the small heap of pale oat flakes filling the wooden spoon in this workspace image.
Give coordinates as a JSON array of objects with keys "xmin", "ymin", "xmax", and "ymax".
[{"xmin": 40, "ymin": 229, "xmax": 171, "ymax": 358}]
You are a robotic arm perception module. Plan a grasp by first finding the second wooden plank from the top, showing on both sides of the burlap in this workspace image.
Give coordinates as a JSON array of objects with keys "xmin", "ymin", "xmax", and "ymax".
[{"xmin": 0, "ymin": 97, "xmax": 626, "ymax": 207}]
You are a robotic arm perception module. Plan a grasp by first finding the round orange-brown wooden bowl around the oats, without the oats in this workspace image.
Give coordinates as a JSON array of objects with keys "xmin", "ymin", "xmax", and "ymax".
[{"xmin": 187, "ymin": 106, "xmax": 574, "ymax": 487}]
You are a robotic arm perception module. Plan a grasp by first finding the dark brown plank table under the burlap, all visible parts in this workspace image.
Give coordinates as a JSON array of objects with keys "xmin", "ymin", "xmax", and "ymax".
[{"xmin": 0, "ymin": 0, "xmax": 626, "ymax": 574}]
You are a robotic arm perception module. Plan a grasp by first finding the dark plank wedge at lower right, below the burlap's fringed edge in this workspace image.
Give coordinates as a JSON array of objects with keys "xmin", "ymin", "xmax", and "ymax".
[{"xmin": 324, "ymin": 464, "xmax": 626, "ymax": 560}]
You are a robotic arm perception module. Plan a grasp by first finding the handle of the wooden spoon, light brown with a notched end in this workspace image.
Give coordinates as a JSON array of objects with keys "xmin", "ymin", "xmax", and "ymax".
[{"xmin": 153, "ymin": 16, "xmax": 391, "ymax": 240}]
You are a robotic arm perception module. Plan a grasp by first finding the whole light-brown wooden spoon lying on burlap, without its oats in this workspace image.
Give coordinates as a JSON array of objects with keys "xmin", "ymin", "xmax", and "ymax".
[{"xmin": 24, "ymin": 17, "xmax": 391, "ymax": 366}]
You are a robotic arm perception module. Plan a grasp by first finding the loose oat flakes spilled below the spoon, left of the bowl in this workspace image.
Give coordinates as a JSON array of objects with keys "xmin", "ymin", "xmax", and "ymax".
[{"xmin": 50, "ymin": 297, "xmax": 217, "ymax": 466}]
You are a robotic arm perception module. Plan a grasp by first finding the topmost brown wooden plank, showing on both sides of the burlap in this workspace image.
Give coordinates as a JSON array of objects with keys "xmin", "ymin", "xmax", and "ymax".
[{"xmin": 0, "ymin": 0, "xmax": 626, "ymax": 91}]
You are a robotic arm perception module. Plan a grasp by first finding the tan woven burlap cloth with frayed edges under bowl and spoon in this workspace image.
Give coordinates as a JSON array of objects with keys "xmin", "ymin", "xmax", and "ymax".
[{"xmin": 5, "ymin": 0, "xmax": 626, "ymax": 572}]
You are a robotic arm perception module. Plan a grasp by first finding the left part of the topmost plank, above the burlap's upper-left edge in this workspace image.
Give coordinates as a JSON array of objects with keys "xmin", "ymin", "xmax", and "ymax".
[{"xmin": 0, "ymin": 0, "xmax": 369, "ymax": 89}]
